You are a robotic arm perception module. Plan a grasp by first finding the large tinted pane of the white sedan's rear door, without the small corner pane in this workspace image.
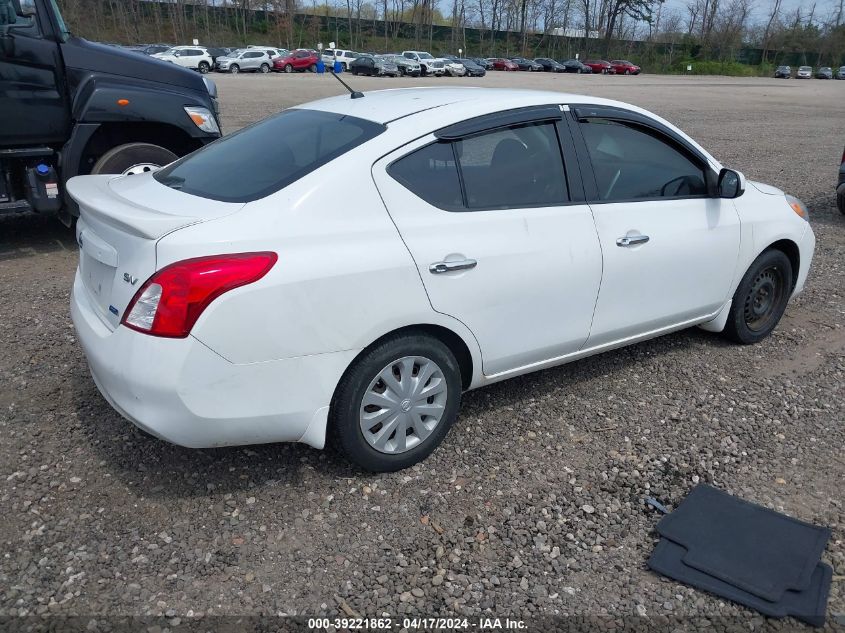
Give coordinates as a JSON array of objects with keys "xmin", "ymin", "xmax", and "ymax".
[{"xmin": 456, "ymin": 123, "xmax": 567, "ymax": 209}]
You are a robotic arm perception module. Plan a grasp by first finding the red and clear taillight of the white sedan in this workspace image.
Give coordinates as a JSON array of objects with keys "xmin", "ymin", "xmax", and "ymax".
[{"xmin": 121, "ymin": 252, "xmax": 278, "ymax": 338}]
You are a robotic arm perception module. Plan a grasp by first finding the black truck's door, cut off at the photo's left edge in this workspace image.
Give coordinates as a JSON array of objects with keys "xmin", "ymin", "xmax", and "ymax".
[{"xmin": 0, "ymin": 2, "xmax": 71, "ymax": 147}]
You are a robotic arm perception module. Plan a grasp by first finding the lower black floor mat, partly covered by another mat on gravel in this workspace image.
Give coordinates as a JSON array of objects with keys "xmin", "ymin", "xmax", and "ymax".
[{"xmin": 648, "ymin": 538, "xmax": 833, "ymax": 626}]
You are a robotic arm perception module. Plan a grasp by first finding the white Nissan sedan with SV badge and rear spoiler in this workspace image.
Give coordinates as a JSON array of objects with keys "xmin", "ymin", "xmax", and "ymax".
[{"xmin": 68, "ymin": 88, "xmax": 815, "ymax": 471}]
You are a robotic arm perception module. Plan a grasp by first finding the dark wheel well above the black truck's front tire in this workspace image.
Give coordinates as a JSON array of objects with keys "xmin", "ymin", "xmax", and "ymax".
[{"xmin": 79, "ymin": 122, "xmax": 202, "ymax": 175}]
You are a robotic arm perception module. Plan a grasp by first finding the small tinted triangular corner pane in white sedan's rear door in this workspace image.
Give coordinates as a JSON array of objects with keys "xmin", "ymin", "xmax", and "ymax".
[{"xmin": 388, "ymin": 143, "xmax": 463, "ymax": 209}]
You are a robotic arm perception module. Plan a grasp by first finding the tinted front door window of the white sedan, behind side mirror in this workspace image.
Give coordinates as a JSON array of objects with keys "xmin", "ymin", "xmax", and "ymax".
[{"xmin": 581, "ymin": 119, "xmax": 707, "ymax": 200}]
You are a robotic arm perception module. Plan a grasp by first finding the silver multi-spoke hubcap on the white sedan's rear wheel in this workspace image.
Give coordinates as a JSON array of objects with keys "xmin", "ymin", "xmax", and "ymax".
[{"xmin": 359, "ymin": 356, "xmax": 448, "ymax": 454}]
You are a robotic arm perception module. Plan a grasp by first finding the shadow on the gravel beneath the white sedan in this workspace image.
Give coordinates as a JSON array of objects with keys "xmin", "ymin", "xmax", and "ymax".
[{"xmin": 73, "ymin": 329, "xmax": 730, "ymax": 503}]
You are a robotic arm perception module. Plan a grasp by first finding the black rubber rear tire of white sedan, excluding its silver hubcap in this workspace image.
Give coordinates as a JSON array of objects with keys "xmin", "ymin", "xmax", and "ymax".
[{"xmin": 328, "ymin": 333, "xmax": 461, "ymax": 472}]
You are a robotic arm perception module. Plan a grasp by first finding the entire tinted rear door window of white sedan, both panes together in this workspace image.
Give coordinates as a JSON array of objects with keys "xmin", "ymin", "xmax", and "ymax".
[{"xmin": 388, "ymin": 123, "xmax": 569, "ymax": 211}]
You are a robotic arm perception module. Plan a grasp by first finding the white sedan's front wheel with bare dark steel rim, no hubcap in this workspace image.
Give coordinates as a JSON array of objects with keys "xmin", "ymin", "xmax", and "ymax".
[{"xmin": 724, "ymin": 249, "xmax": 792, "ymax": 345}]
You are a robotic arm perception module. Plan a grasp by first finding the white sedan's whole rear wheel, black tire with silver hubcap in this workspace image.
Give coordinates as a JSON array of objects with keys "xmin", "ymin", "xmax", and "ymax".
[{"xmin": 329, "ymin": 334, "xmax": 461, "ymax": 472}]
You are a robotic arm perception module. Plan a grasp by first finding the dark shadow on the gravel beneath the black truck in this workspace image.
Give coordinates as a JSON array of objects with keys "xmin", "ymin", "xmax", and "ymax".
[{"xmin": 0, "ymin": 213, "xmax": 77, "ymax": 262}]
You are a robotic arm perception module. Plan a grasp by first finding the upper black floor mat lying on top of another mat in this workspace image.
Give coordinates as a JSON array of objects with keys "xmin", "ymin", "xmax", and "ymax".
[{"xmin": 657, "ymin": 484, "xmax": 830, "ymax": 602}]
